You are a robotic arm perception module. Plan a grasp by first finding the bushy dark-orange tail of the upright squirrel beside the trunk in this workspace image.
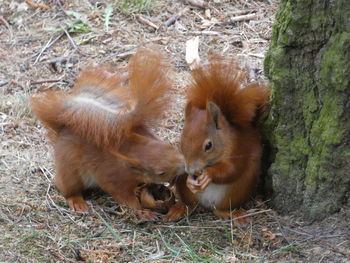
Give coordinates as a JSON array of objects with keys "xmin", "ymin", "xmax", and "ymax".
[{"xmin": 187, "ymin": 56, "xmax": 269, "ymax": 126}]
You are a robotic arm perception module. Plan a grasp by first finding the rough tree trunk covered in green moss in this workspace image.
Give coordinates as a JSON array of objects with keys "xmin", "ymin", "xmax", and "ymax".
[{"xmin": 265, "ymin": 0, "xmax": 350, "ymax": 219}]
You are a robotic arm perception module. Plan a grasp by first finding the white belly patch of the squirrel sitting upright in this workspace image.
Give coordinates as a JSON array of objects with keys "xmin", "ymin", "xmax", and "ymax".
[{"xmin": 196, "ymin": 183, "xmax": 229, "ymax": 208}]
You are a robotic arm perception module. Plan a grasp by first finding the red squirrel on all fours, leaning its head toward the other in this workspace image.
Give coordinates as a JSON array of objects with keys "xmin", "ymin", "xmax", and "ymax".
[{"xmin": 32, "ymin": 49, "xmax": 184, "ymax": 219}]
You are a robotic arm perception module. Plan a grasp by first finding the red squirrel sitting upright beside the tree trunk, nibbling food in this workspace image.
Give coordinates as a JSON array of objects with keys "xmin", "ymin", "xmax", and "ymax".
[{"xmin": 166, "ymin": 56, "xmax": 269, "ymax": 220}]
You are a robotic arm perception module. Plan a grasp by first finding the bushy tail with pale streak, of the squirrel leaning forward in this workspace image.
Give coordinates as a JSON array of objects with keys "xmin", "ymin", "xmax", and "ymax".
[{"xmin": 32, "ymin": 48, "xmax": 170, "ymax": 147}]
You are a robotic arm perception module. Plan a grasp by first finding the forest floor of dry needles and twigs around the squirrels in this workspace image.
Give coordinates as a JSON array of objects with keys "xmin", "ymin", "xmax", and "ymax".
[{"xmin": 0, "ymin": 0, "xmax": 350, "ymax": 262}]
